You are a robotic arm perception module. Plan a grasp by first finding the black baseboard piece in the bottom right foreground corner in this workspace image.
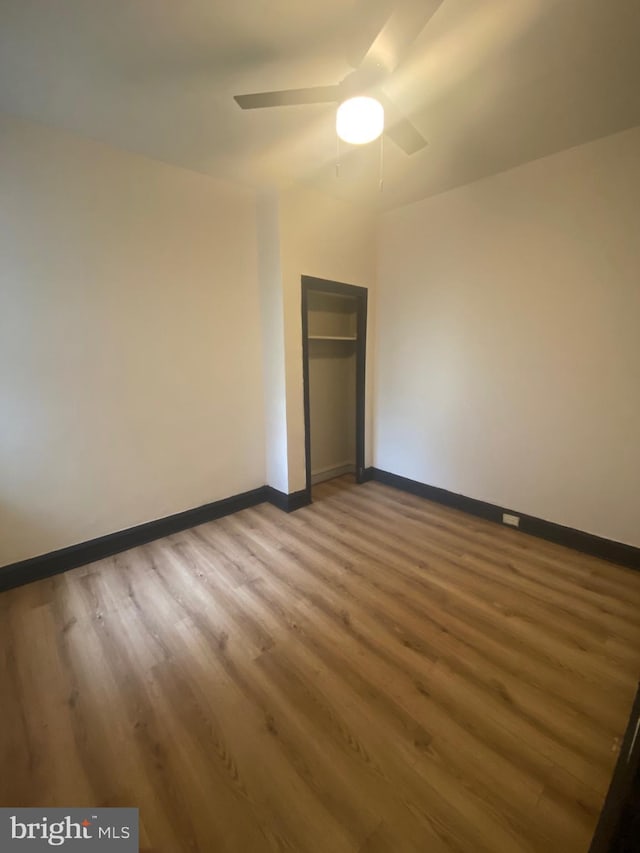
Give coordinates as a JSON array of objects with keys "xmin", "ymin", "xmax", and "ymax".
[{"xmin": 589, "ymin": 688, "xmax": 640, "ymax": 853}]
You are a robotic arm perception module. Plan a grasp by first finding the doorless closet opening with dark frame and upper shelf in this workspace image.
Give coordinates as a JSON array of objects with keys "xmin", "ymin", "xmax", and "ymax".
[{"xmin": 302, "ymin": 276, "xmax": 367, "ymax": 499}]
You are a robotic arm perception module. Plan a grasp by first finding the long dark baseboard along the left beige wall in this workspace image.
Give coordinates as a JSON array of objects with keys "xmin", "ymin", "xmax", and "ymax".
[{"xmin": 0, "ymin": 486, "xmax": 267, "ymax": 591}]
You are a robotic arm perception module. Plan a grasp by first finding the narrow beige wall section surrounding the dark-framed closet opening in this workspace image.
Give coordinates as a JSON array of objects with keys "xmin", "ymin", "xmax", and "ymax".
[{"xmin": 280, "ymin": 189, "xmax": 376, "ymax": 492}]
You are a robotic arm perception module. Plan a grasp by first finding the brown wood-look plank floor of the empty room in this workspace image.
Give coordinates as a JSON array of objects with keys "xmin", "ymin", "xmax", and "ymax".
[{"xmin": 0, "ymin": 478, "xmax": 640, "ymax": 853}]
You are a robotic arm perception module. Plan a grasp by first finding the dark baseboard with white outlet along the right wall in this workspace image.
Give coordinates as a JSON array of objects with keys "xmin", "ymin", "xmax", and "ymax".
[{"xmin": 367, "ymin": 468, "xmax": 640, "ymax": 570}]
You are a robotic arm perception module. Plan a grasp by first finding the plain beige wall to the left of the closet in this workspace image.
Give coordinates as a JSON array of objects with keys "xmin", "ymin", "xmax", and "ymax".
[{"xmin": 0, "ymin": 113, "xmax": 265, "ymax": 565}]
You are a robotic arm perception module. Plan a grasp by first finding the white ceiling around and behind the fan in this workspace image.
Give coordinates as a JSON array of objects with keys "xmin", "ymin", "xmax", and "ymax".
[{"xmin": 0, "ymin": 0, "xmax": 640, "ymax": 207}]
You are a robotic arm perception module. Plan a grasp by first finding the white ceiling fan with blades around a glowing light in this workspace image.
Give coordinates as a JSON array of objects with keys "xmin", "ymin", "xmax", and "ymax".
[{"xmin": 234, "ymin": 0, "xmax": 442, "ymax": 154}]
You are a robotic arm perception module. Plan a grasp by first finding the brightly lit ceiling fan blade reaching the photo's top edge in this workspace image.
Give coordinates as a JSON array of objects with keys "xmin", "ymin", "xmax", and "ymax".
[{"xmin": 360, "ymin": 0, "xmax": 443, "ymax": 73}]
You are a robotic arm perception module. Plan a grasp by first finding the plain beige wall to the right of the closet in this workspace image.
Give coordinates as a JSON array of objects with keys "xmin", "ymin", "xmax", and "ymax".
[{"xmin": 375, "ymin": 129, "xmax": 640, "ymax": 545}]
